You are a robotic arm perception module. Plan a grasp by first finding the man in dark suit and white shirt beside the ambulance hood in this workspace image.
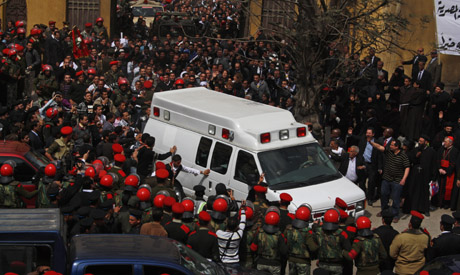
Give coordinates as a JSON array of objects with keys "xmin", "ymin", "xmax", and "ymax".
[{"xmin": 331, "ymin": 145, "xmax": 366, "ymax": 191}]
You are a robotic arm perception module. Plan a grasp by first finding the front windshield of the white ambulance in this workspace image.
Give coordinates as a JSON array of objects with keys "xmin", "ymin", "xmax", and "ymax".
[{"xmin": 258, "ymin": 143, "xmax": 341, "ymax": 190}]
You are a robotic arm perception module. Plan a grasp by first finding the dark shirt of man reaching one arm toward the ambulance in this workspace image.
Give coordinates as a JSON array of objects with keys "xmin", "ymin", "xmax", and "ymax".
[{"xmin": 382, "ymin": 148, "xmax": 410, "ymax": 183}]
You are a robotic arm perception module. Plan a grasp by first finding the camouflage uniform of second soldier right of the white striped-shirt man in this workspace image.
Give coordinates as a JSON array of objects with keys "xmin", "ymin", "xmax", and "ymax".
[{"xmin": 284, "ymin": 225, "xmax": 318, "ymax": 275}]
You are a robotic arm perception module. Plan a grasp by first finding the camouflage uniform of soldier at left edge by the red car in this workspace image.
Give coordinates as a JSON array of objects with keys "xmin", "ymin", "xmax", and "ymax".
[{"xmin": 0, "ymin": 181, "xmax": 38, "ymax": 208}]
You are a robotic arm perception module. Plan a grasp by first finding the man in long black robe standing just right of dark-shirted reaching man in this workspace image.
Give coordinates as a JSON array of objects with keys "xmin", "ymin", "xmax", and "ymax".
[{"xmin": 405, "ymin": 135, "xmax": 436, "ymax": 216}]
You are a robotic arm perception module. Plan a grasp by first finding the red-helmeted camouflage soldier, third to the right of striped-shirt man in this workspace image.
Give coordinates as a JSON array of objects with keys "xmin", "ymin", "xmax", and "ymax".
[{"xmin": 313, "ymin": 209, "xmax": 351, "ymax": 275}]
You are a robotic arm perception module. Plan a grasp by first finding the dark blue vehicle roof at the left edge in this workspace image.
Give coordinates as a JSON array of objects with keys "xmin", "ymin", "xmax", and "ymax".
[{"xmin": 0, "ymin": 208, "xmax": 64, "ymax": 233}]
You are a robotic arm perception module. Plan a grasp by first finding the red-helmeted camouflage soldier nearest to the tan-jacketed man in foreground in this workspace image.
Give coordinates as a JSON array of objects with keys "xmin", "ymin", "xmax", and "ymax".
[{"xmin": 343, "ymin": 216, "xmax": 387, "ymax": 275}]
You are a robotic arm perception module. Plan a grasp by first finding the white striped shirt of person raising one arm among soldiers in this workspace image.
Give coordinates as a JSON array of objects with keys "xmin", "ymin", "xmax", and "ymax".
[{"xmin": 216, "ymin": 212, "xmax": 246, "ymax": 264}]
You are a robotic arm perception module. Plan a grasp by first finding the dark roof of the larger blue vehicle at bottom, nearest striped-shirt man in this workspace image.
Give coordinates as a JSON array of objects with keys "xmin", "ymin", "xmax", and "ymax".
[{"xmin": 70, "ymin": 234, "xmax": 180, "ymax": 264}]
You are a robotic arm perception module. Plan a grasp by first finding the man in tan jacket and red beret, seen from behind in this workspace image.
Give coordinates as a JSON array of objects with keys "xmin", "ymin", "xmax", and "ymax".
[{"xmin": 390, "ymin": 211, "xmax": 430, "ymax": 275}]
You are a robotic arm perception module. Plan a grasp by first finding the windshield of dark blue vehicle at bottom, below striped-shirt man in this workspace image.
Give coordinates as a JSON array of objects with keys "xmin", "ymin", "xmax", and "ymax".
[{"xmin": 173, "ymin": 242, "xmax": 225, "ymax": 275}]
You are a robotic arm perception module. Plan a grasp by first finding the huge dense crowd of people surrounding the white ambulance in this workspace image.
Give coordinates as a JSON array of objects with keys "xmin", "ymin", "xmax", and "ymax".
[{"xmin": 0, "ymin": 0, "xmax": 460, "ymax": 274}]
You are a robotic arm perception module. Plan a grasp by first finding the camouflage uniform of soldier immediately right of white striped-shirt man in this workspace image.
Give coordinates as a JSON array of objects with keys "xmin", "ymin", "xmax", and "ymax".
[{"xmin": 251, "ymin": 228, "xmax": 288, "ymax": 275}]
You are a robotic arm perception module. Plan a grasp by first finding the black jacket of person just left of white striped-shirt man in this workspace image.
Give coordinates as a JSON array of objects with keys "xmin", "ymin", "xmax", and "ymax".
[{"xmin": 187, "ymin": 227, "xmax": 219, "ymax": 261}]
